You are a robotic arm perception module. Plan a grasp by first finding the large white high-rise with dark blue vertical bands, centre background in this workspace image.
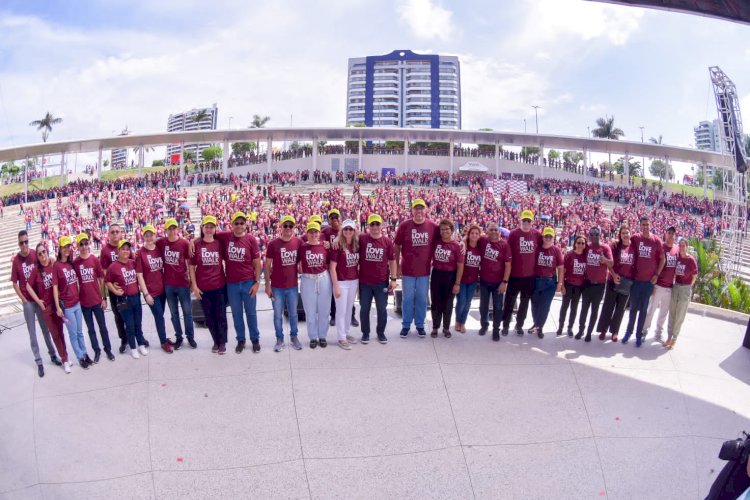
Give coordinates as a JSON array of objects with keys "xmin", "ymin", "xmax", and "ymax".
[{"xmin": 346, "ymin": 50, "xmax": 461, "ymax": 129}]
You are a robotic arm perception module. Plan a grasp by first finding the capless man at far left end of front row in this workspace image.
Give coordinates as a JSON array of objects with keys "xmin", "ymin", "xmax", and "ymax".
[{"xmin": 10, "ymin": 231, "xmax": 62, "ymax": 377}]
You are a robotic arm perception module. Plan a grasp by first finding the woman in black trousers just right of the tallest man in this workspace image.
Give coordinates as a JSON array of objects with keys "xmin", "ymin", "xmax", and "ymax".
[{"xmin": 430, "ymin": 219, "xmax": 464, "ymax": 338}]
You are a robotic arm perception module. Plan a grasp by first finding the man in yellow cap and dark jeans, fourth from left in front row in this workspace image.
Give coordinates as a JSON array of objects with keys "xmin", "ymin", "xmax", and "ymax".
[{"xmin": 73, "ymin": 233, "xmax": 115, "ymax": 363}]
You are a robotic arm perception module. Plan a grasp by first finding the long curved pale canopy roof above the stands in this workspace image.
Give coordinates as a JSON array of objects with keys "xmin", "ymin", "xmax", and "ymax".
[{"xmin": 0, "ymin": 127, "xmax": 731, "ymax": 166}]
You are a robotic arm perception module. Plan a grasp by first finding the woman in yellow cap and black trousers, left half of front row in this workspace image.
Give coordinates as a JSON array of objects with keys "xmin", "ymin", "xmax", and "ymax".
[{"xmin": 190, "ymin": 219, "xmax": 227, "ymax": 354}]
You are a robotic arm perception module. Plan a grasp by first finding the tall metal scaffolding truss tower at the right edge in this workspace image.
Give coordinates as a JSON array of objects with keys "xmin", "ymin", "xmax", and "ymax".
[{"xmin": 708, "ymin": 66, "xmax": 747, "ymax": 282}]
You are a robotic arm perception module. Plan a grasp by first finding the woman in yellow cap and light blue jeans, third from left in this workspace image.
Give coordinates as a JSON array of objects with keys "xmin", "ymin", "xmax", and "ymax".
[{"xmin": 52, "ymin": 236, "xmax": 94, "ymax": 370}]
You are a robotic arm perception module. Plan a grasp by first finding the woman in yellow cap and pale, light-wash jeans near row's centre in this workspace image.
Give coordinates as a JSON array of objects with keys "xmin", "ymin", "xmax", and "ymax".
[{"xmin": 297, "ymin": 222, "xmax": 331, "ymax": 349}]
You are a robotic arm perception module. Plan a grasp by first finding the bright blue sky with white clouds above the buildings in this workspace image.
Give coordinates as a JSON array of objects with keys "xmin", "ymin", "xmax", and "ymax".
[{"xmin": 0, "ymin": 0, "xmax": 750, "ymax": 174}]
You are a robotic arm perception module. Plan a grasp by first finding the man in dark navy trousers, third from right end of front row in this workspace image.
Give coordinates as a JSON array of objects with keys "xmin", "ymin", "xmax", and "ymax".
[{"xmin": 622, "ymin": 215, "xmax": 666, "ymax": 347}]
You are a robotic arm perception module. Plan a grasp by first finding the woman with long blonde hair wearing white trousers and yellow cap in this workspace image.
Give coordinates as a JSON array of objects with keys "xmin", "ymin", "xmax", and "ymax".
[{"xmin": 330, "ymin": 219, "xmax": 359, "ymax": 351}]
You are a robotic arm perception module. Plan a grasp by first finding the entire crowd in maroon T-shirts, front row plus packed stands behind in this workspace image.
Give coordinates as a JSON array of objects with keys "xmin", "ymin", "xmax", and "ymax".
[{"xmin": 11, "ymin": 172, "xmax": 704, "ymax": 375}]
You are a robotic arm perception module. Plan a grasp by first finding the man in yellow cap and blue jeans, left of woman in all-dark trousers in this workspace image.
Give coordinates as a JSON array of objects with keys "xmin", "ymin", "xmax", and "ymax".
[{"xmin": 156, "ymin": 219, "xmax": 198, "ymax": 351}]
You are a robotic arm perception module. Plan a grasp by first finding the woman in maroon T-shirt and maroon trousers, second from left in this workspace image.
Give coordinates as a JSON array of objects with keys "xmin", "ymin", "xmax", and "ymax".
[{"xmin": 26, "ymin": 243, "xmax": 70, "ymax": 373}]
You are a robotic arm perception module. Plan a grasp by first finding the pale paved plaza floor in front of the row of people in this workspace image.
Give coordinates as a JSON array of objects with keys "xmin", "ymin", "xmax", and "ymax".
[{"xmin": 0, "ymin": 296, "xmax": 750, "ymax": 500}]
